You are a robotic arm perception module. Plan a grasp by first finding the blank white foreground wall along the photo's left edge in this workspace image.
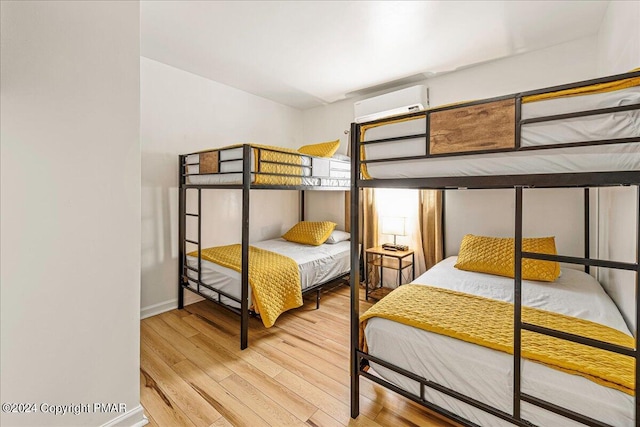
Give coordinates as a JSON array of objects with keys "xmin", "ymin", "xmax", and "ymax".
[{"xmin": 0, "ymin": 1, "xmax": 143, "ymax": 426}]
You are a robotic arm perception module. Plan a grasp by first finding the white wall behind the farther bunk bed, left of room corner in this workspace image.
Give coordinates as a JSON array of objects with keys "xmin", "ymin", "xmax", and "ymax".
[{"xmin": 140, "ymin": 58, "xmax": 305, "ymax": 317}]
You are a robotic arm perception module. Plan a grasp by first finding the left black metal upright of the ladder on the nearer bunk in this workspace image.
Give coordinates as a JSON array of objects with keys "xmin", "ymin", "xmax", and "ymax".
[{"xmin": 513, "ymin": 186, "xmax": 522, "ymax": 420}]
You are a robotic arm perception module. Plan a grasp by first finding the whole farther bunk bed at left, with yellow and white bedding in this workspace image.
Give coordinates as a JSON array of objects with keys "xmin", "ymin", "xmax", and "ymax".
[{"xmin": 178, "ymin": 141, "xmax": 351, "ymax": 349}]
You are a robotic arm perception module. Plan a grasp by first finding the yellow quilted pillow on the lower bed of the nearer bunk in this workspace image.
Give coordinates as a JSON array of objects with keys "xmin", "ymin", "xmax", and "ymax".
[{"xmin": 455, "ymin": 234, "xmax": 560, "ymax": 282}]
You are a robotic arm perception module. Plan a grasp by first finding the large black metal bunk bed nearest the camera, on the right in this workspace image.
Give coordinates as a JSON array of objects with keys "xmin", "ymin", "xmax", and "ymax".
[{"xmin": 350, "ymin": 71, "xmax": 640, "ymax": 426}]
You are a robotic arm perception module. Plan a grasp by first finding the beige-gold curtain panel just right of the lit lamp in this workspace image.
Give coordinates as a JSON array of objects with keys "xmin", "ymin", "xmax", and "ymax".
[{"xmin": 419, "ymin": 190, "xmax": 444, "ymax": 270}]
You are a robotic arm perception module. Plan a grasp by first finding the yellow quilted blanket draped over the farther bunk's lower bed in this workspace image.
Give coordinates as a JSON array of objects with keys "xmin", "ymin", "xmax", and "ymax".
[{"xmin": 188, "ymin": 245, "xmax": 302, "ymax": 328}]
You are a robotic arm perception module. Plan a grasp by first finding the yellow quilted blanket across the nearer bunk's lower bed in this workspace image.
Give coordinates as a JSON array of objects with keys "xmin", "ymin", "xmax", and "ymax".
[{"xmin": 360, "ymin": 285, "xmax": 635, "ymax": 395}]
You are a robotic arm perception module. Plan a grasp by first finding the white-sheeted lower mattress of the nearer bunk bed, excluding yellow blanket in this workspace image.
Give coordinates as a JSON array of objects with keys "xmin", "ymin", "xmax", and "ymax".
[{"xmin": 365, "ymin": 257, "xmax": 635, "ymax": 427}]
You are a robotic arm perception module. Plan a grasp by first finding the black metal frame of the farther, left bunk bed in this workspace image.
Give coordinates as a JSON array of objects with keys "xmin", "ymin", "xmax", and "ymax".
[{"xmin": 178, "ymin": 144, "xmax": 349, "ymax": 350}]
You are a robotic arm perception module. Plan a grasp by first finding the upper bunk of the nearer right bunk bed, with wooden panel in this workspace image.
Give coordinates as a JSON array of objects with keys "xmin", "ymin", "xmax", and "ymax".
[{"xmin": 351, "ymin": 70, "xmax": 640, "ymax": 188}]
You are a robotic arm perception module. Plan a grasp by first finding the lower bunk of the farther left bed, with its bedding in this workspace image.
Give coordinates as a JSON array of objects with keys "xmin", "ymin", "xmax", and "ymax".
[{"xmin": 182, "ymin": 237, "xmax": 350, "ymax": 327}]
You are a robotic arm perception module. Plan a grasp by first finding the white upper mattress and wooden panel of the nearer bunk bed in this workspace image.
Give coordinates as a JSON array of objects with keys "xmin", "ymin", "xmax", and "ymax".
[{"xmin": 361, "ymin": 79, "xmax": 640, "ymax": 179}]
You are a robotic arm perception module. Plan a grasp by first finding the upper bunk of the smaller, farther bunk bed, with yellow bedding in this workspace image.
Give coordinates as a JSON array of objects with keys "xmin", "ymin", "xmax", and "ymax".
[{"xmin": 180, "ymin": 141, "xmax": 351, "ymax": 191}]
